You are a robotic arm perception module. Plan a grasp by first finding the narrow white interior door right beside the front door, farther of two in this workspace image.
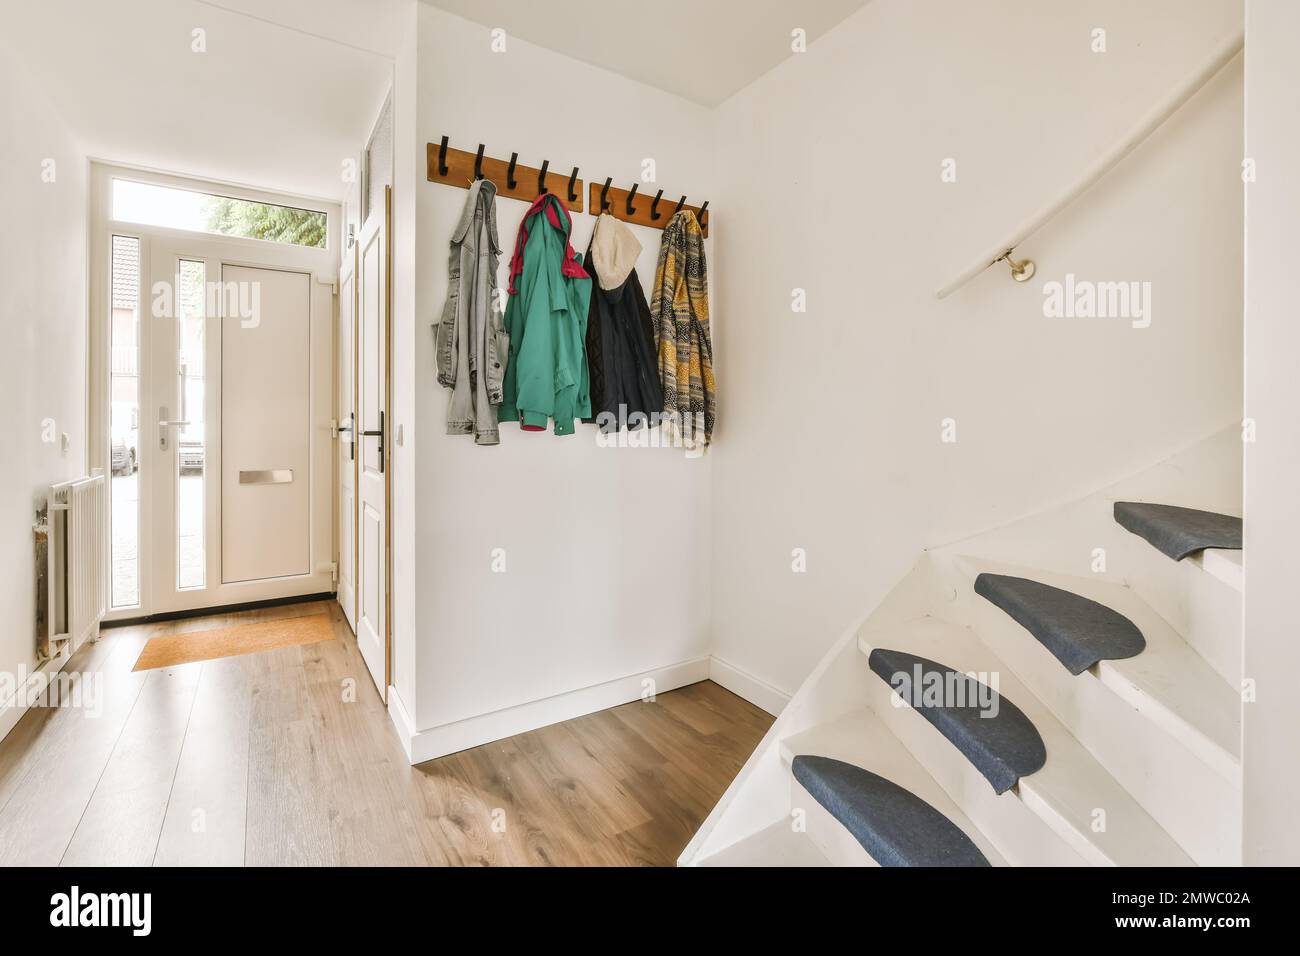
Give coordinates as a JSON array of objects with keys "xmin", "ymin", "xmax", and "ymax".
[{"xmin": 335, "ymin": 243, "xmax": 358, "ymax": 632}]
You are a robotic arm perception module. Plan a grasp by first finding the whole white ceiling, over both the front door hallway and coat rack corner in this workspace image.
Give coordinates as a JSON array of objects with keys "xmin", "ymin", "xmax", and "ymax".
[{"xmin": 0, "ymin": 0, "xmax": 868, "ymax": 199}]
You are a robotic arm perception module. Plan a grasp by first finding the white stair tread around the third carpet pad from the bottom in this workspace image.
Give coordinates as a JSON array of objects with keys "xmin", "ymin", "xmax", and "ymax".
[{"xmin": 957, "ymin": 557, "xmax": 1242, "ymax": 780}]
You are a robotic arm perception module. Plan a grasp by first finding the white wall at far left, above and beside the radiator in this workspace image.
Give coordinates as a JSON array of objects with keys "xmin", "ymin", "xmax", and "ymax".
[{"xmin": 0, "ymin": 49, "xmax": 87, "ymax": 717}]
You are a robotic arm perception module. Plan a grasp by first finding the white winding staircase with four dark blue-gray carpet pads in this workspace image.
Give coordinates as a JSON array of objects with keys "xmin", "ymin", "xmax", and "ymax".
[{"xmin": 679, "ymin": 429, "xmax": 1243, "ymax": 866}]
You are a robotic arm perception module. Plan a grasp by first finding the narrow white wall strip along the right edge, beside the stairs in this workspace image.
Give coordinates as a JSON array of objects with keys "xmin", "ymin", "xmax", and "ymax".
[{"xmin": 1242, "ymin": 0, "xmax": 1300, "ymax": 866}]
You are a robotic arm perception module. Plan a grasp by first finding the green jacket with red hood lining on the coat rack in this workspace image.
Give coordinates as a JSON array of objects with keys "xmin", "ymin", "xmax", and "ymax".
[{"xmin": 498, "ymin": 193, "xmax": 592, "ymax": 434}]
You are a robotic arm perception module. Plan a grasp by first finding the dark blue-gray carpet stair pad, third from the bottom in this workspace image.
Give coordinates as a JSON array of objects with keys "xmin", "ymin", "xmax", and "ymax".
[{"xmin": 975, "ymin": 574, "xmax": 1147, "ymax": 674}]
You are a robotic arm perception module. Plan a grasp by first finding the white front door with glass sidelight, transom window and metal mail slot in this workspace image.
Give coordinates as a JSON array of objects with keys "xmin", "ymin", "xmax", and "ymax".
[{"xmin": 98, "ymin": 163, "xmax": 338, "ymax": 620}]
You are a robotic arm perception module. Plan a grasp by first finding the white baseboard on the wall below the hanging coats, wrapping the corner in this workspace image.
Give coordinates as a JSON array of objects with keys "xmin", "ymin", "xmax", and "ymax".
[{"xmin": 389, "ymin": 657, "xmax": 712, "ymax": 763}]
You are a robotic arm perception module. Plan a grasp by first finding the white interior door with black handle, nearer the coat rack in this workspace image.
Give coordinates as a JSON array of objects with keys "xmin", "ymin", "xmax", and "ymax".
[{"xmin": 356, "ymin": 190, "xmax": 391, "ymax": 700}]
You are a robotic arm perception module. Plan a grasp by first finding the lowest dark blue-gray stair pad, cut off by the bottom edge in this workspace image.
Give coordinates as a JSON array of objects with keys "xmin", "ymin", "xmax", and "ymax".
[{"xmin": 792, "ymin": 754, "xmax": 989, "ymax": 866}]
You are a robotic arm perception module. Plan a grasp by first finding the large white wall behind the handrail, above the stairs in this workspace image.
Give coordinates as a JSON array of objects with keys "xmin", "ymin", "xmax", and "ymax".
[{"xmin": 712, "ymin": 0, "xmax": 1242, "ymax": 692}]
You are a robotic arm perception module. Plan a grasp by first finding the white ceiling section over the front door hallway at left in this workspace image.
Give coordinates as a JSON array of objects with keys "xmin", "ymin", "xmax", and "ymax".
[{"xmin": 0, "ymin": 0, "xmax": 393, "ymax": 199}]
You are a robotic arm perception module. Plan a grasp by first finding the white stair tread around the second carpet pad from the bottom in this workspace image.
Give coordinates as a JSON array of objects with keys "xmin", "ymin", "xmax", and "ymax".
[{"xmin": 858, "ymin": 618, "xmax": 1192, "ymax": 866}]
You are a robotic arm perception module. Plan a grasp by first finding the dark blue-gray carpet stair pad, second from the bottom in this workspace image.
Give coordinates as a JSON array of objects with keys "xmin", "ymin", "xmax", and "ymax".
[{"xmin": 867, "ymin": 648, "xmax": 1048, "ymax": 793}]
